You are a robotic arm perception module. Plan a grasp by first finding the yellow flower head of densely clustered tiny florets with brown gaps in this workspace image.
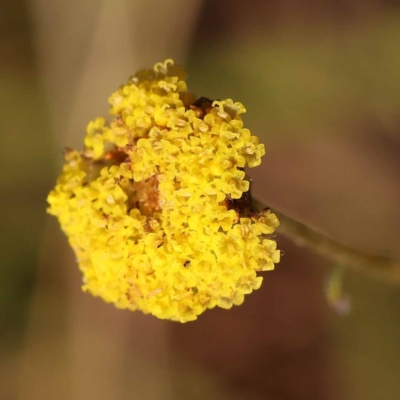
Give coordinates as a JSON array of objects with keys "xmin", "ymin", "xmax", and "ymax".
[{"xmin": 48, "ymin": 60, "xmax": 280, "ymax": 322}]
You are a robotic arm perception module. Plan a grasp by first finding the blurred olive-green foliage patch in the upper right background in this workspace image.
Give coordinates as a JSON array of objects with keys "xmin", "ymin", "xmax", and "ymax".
[{"xmin": 189, "ymin": 13, "xmax": 400, "ymax": 145}]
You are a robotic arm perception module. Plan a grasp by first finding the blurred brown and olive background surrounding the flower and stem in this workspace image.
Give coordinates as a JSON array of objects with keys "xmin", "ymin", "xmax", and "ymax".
[{"xmin": 0, "ymin": 0, "xmax": 400, "ymax": 400}]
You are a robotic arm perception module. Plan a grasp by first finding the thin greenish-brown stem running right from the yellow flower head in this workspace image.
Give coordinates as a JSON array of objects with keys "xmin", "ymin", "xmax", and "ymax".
[{"xmin": 253, "ymin": 199, "xmax": 400, "ymax": 284}]
